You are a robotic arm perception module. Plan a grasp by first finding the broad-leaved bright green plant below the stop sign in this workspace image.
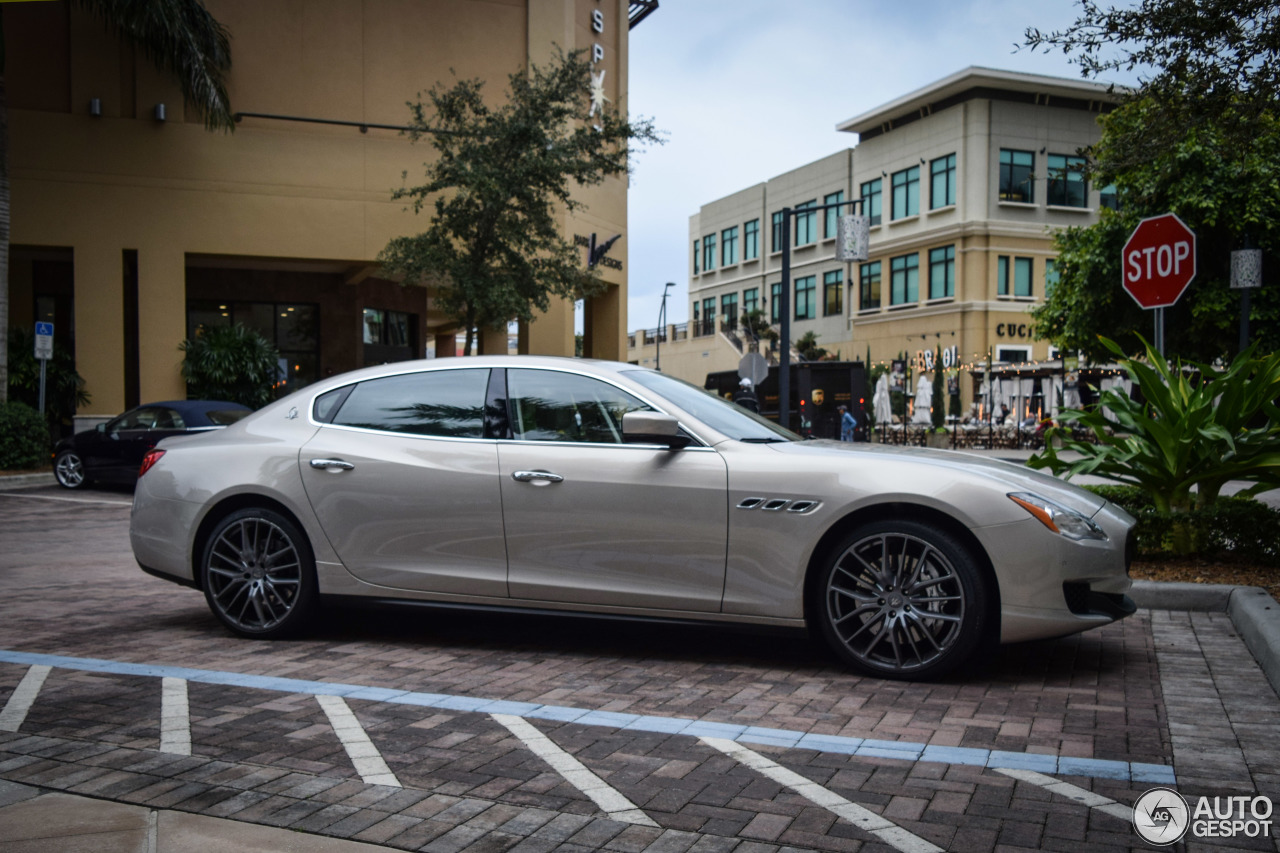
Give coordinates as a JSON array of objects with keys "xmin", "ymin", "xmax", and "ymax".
[{"xmin": 1028, "ymin": 339, "xmax": 1280, "ymax": 553}]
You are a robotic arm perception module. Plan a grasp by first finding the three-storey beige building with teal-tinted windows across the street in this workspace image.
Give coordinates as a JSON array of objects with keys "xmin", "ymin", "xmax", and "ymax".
[{"xmin": 628, "ymin": 68, "xmax": 1114, "ymax": 403}]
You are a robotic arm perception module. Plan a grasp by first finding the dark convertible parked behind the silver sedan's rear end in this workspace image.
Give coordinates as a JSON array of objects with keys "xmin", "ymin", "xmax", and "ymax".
[{"xmin": 54, "ymin": 400, "xmax": 253, "ymax": 489}]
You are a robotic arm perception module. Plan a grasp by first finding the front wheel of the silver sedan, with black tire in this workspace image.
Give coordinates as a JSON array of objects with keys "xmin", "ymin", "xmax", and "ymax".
[{"xmin": 810, "ymin": 520, "xmax": 997, "ymax": 680}]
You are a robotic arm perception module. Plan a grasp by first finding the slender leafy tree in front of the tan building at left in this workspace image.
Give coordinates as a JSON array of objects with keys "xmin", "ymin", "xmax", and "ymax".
[{"xmin": 379, "ymin": 51, "xmax": 660, "ymax": 355}]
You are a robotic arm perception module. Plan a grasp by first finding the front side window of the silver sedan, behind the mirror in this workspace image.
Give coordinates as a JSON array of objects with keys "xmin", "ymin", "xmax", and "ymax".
[{"xmin": 507, "ymin": 370, "xmax": 650, "ymax": 444}]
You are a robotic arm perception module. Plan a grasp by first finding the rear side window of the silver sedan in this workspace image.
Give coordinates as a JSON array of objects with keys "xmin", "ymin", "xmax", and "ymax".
[{"xmin": 333, "ymin": 369, "xmax": 489, "ymax": 438}]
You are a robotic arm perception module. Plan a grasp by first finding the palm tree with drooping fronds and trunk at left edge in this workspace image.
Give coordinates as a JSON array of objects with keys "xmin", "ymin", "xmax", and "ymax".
[{"xmin": 0, "ymin": 0, "xmax": 236, "ymax": 403}]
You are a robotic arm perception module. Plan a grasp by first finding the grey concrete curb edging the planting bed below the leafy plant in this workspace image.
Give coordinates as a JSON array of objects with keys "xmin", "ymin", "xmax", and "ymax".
[{"xmin": 1129, "ymin": 580, "xmax": 1280, "ymax": 695}]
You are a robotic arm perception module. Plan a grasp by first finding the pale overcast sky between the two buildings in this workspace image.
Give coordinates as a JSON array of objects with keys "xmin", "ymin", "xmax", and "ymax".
[{"xmin": 627, "ymin": 0, "xmax": 1134, "ymax": 330}]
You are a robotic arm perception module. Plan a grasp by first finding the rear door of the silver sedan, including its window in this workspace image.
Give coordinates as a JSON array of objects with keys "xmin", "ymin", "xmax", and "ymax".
[{"xmin": 298, "ymin": 368, "xmax": 507, "ymax": 597}]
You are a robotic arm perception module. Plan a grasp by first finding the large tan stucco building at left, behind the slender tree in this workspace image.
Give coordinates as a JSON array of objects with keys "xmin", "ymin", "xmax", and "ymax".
[{"xmin": 5, "ymin": 0, "xmax": 628, "ymax": 420}]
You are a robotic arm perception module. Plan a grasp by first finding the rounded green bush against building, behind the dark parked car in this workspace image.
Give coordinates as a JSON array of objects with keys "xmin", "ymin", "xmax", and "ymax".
[{"xmin": 178, "ymin": 323, "xmax": 280, "ymax": 409}]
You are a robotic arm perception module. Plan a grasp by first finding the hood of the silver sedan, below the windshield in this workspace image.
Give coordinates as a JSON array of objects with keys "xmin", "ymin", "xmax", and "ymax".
[{"xmin": 764, "ymin": 439, "xmax": 1106, "ymax": 517}]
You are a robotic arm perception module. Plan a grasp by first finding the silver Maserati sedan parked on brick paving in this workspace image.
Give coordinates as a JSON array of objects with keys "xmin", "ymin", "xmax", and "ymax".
[{"xmin": 131, "ymin": 356, "xmax": 1134, "ymax": 679}]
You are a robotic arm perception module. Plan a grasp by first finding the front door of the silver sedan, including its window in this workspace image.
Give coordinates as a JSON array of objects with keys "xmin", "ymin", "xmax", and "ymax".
[{"xmin": 498, "ymin": 369, "xmax": 728, "ymax": 612}]
